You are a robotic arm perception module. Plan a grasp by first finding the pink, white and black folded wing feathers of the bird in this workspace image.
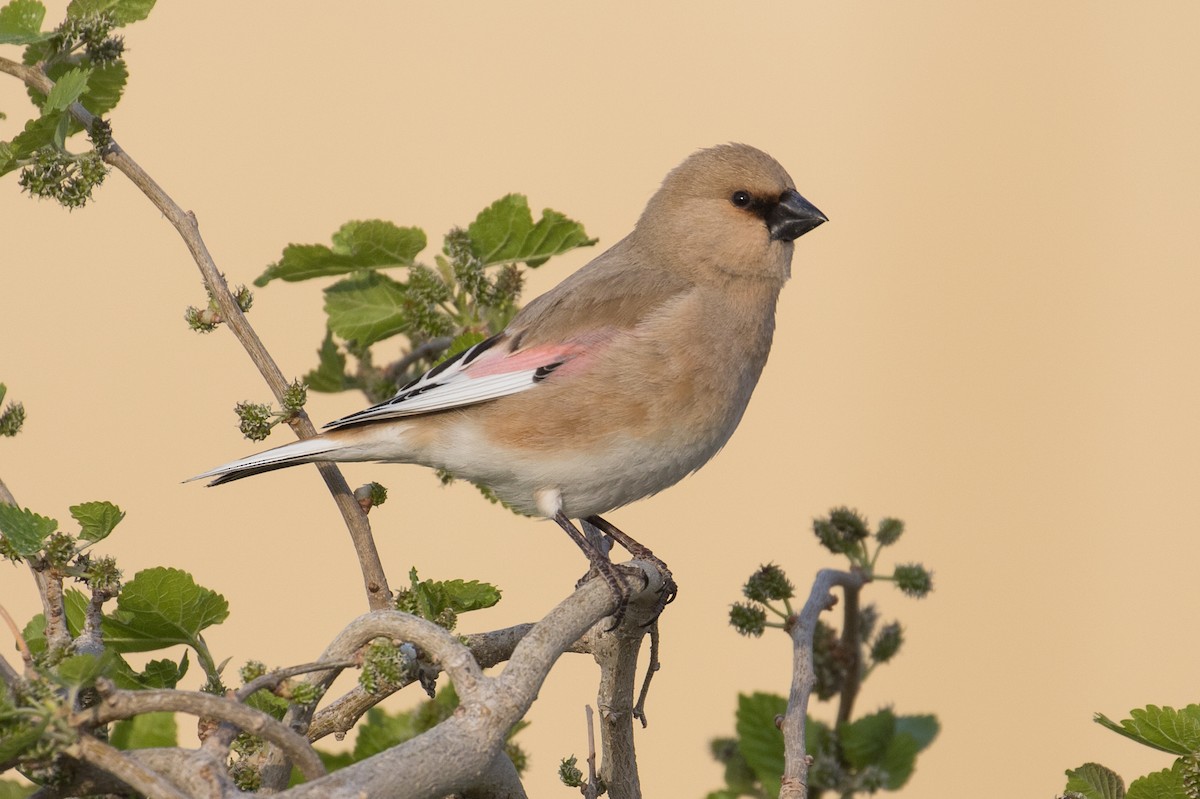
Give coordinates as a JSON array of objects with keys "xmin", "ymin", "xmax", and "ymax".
[{"xmin": 325, "ymin": 332, "xmax": 587, "ymax": 428}]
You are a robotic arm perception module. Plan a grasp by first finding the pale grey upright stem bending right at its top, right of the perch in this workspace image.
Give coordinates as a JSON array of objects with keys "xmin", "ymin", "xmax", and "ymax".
[{"xmin": 779, "ymin": 569, "xmax": 865, "ymax": 799}]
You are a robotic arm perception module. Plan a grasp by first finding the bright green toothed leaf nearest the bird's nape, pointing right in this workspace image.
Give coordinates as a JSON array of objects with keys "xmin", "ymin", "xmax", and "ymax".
[{"xmin": 467, "ymin": 194, "xmax": 596, "ymax": 266}]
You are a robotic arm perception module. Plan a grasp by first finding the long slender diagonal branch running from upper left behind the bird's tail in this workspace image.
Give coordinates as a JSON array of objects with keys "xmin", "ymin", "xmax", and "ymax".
[{"xmin": 0, "ymin": 52, "xmax": 391, "ymax": 609}]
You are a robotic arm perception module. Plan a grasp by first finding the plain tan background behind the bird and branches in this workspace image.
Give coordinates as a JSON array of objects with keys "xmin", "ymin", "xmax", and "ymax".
[{"xmin": 0, "ymin": 0, "xmax": 1200, "ymax": 797}]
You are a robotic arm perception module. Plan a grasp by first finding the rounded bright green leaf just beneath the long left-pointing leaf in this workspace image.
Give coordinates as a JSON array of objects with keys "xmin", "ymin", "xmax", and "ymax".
[{"xmin": 325, "ymin": 271, "xmax": 410, "ymax": 347}]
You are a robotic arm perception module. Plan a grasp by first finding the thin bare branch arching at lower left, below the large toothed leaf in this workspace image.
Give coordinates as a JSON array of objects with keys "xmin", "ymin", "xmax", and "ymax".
[{"xmin": 71, "ymin": 681, "xmax": 325, "ymax": 780}]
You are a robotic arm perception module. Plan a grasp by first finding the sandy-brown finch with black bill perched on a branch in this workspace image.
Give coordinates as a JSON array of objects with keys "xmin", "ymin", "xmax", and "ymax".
[{"xmin": 191, "ymin": 143, "xmax": 828, "ymax": 626}]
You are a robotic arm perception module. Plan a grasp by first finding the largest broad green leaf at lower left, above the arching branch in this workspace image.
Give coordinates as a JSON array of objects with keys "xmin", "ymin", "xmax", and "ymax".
[{"xmin": 103, "ymin": 567, "xmax": 229, "ymax": 653}]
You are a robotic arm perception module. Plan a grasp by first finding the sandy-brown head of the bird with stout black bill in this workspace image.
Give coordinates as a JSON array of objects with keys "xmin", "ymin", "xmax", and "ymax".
[{"xmin": 637, "ymin": 144, "xmax": 827, "ymax": 283}]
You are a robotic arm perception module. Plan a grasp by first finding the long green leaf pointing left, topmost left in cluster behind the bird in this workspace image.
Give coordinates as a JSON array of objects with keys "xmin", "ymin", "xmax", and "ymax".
[{"xmin": 254, "ymin": 220, "xmax": 426, "ymax": 286}]
